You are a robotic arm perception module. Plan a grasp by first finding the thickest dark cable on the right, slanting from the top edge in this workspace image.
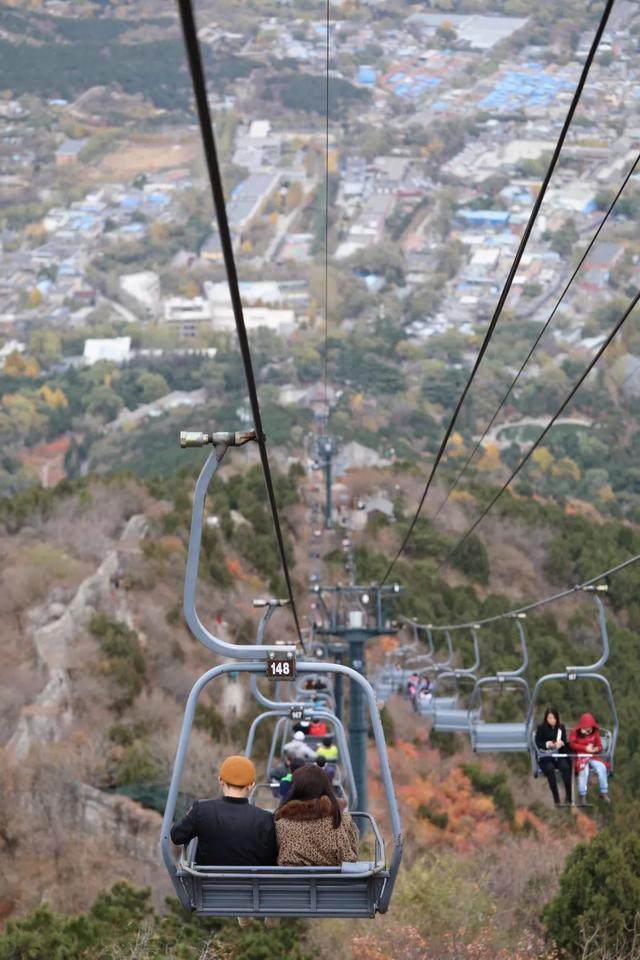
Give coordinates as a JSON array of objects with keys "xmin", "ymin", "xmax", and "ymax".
[{"xmin": 381, "ymin": 0, "xmax": 615, "ymax": 584}]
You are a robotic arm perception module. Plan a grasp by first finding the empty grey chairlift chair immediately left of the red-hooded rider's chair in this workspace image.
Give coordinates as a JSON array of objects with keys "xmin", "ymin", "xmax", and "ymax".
[{"xmin": 469, "ymin": 614, "xmax": 531, "ymax": 753}]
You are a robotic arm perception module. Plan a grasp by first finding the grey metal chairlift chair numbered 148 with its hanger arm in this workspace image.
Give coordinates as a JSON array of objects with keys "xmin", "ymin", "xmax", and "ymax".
[{"xmin": 160, "ymin": 431, "xmax": 403, "ymax": 918}]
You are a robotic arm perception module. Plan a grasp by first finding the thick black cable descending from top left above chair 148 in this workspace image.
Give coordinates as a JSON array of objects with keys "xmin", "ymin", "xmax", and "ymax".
[{"xmin": 178, "ymin": 0, "xmax": 304, "ymax": 649}]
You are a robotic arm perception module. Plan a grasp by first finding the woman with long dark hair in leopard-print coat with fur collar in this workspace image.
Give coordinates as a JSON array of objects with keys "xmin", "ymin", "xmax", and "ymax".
[{"xmin": 274, "ymin": 764, "xmax": 359, "ymax": 867}]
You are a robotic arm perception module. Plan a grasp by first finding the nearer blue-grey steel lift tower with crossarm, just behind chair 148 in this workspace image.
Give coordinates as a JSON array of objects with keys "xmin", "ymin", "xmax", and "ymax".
[{"xmin": 313, "ymin": 583, "xmax": 401, "ymax": 810}]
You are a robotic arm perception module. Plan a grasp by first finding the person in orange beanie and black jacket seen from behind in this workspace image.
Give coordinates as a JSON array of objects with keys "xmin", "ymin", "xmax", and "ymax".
[{"xmin": 171, "ymin": 756, "xmax": 277, "ymax": 867}]
